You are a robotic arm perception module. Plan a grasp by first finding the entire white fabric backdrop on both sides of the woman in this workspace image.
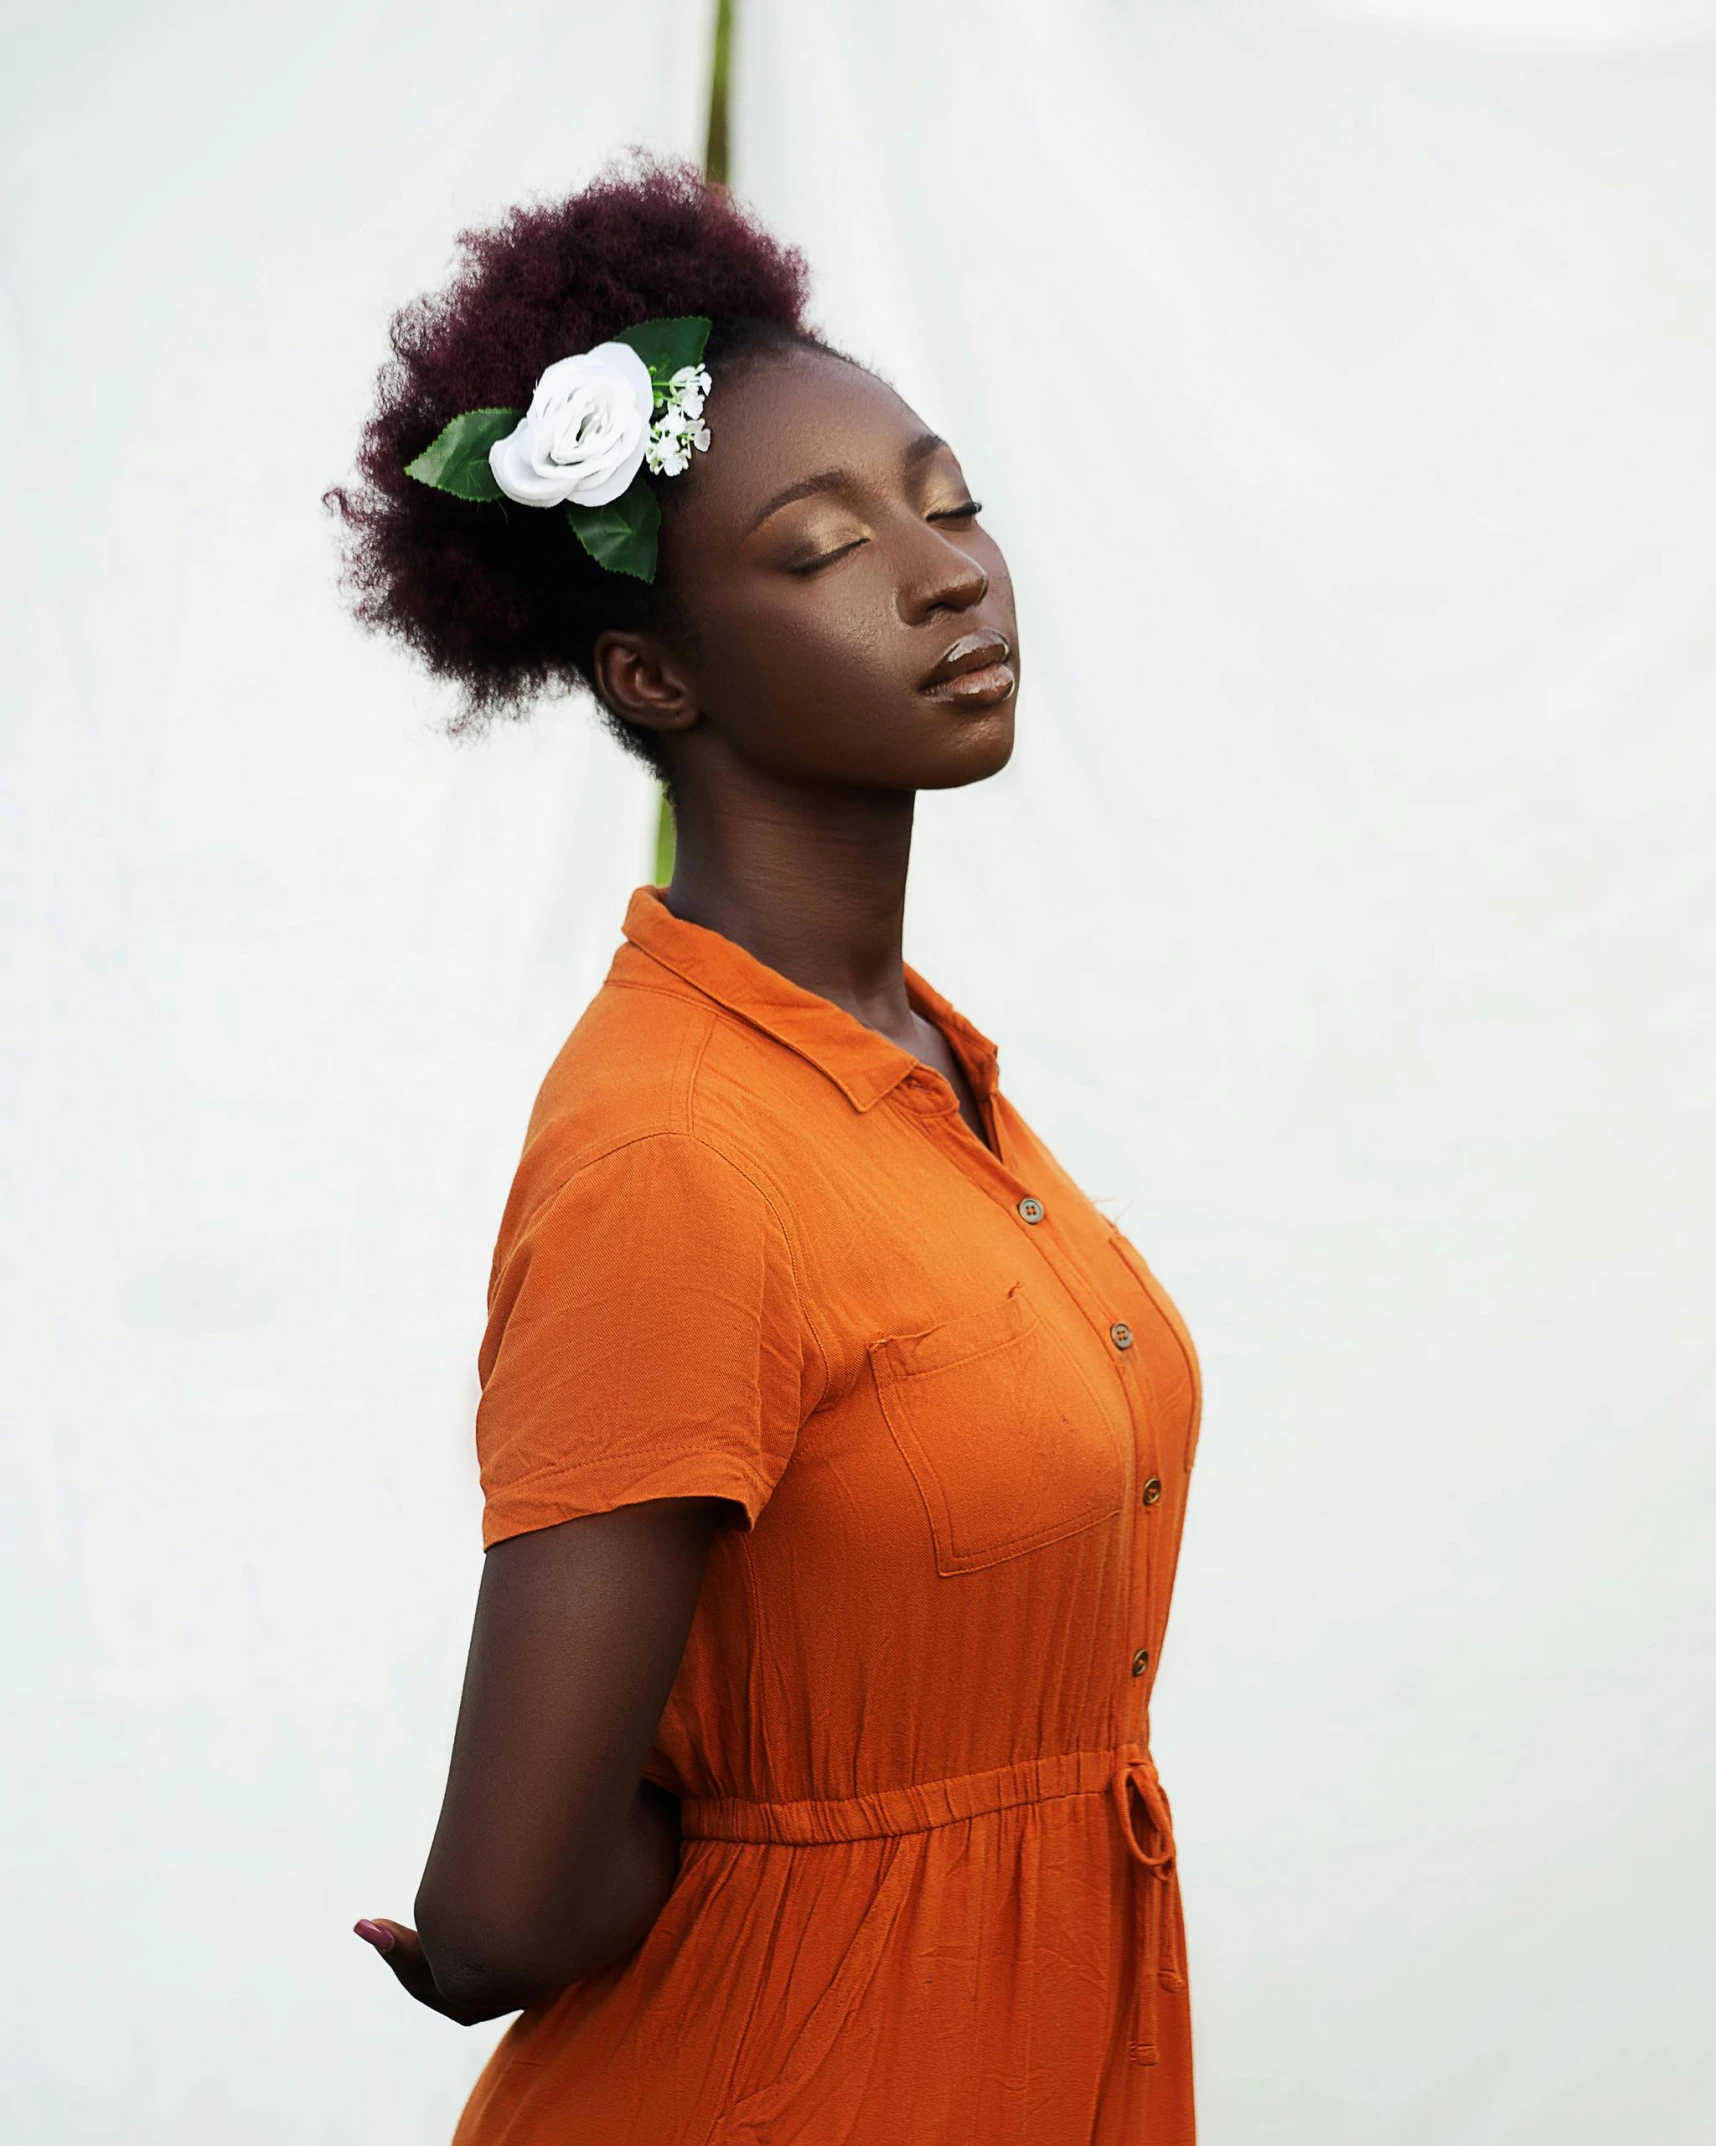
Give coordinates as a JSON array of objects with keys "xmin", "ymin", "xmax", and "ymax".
[{"xmin": 0, "ymin": 0, "xmax": 1716, "ymax": 2146}]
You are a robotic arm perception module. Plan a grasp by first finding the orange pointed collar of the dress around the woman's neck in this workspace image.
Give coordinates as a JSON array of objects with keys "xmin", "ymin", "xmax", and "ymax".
[{"xmin": 624, "ymin": 886, "xmax": 997, "ymax": 1109}]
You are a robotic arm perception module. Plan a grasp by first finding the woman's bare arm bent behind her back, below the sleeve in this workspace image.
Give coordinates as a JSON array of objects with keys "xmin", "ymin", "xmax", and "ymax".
[{"xmin": 360, "ymin": 1498, "xmax": 734, "ymax": 2024}]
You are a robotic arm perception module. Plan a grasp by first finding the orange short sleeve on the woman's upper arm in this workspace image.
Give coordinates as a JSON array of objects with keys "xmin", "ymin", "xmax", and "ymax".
[{"xmin": 476, "ymin": 1133, "xmax": 804, "ymax": 1547}]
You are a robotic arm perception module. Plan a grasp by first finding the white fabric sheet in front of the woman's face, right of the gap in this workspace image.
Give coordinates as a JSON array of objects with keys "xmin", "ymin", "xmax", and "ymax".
[{"xmin": 736, "ymin": 0, "xmax": 1716, "ymax": 2146}]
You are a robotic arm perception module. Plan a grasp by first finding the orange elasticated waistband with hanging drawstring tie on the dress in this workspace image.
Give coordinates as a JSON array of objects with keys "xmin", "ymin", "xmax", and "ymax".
[{"xmin": 680, "ymin": 1743, "xmax": 1186, "ymax": 2064}]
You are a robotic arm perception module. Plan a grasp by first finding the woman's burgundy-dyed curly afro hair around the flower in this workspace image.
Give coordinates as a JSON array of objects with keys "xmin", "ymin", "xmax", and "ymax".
[{"xmin": 326, "ymin": 155, "xmax": 828, "ymax": 766}]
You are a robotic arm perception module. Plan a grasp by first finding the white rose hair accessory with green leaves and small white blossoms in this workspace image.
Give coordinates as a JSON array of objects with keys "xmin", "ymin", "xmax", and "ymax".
[{"xmin": 405, "ymin": 313, "xmax": 712, "ymax": 582}]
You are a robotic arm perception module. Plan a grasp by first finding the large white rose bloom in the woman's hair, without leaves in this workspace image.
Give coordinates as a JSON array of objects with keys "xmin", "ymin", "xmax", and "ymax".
[{"xmin": 489, "ymin": 343, "xmax": 654, "ymax": 506}]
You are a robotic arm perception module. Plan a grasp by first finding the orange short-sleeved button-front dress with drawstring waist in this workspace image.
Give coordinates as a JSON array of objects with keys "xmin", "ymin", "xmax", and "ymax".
[{"xmin": 455, "ymin": 888, "xmax": 1199, "ymax": 2146}]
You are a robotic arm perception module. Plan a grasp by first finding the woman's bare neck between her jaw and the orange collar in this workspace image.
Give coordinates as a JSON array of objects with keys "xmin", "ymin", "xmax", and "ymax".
[{"xmin": 663, "ymin": 753, "xmax": 916, "ymax": 1041}]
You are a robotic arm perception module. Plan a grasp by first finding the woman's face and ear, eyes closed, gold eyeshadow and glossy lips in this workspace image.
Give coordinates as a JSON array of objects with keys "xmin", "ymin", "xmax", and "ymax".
[{"xmin": 596, "ymin": 350, "xmax": 1019, "ymax": 790}]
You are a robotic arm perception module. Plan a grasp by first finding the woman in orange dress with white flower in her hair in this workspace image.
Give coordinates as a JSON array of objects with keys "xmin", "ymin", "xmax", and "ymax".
[{"xmin": 337, "ymin": 165, "xmax": 1199, "ymax": 2146}]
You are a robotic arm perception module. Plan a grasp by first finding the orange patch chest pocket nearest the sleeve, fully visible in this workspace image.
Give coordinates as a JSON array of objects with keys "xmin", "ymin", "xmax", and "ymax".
[{"xmin": 871, "ymin": 1285, "xmax": 1130, "ymax": 1573}]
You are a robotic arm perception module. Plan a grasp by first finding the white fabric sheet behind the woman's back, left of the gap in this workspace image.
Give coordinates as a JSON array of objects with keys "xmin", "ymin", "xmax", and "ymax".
[{"xmin": 0, "ymin": 0, "xmax": 694, "ymax": 2146}]
